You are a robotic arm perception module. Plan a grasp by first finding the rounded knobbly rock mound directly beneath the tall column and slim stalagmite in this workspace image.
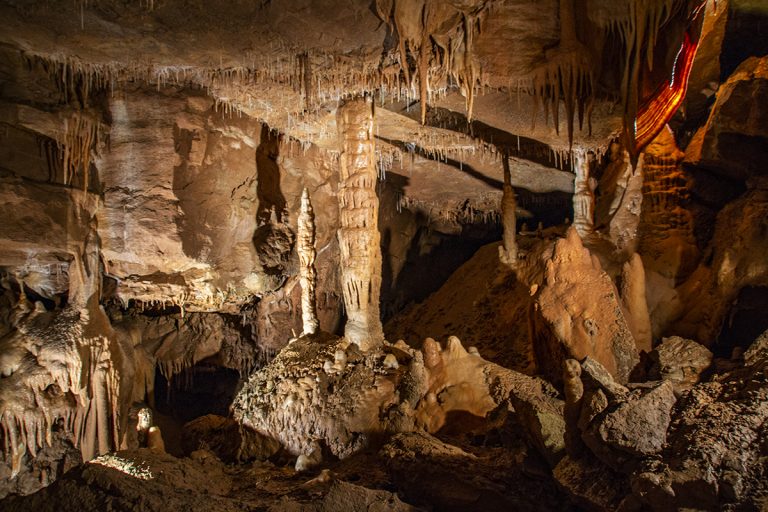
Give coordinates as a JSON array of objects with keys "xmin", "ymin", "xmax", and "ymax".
[{"xmin": 232, "ymin": 332, "xmax": 398, "ymax": 458}]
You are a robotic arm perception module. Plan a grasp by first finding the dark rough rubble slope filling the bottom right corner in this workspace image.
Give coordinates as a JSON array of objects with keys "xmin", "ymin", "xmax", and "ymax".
[{"xmin": 633, "ymin": 330, "xmax": 768, "ymax": 510}]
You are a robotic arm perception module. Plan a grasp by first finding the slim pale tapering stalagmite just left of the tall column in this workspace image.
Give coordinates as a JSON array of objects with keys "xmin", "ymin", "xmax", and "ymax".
[{"xmin": 296, "ymin": 188, "xmax": 318, "ymax": 335}]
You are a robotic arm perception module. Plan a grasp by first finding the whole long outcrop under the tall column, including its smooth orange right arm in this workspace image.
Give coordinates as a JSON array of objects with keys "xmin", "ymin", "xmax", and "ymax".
[{"xmin": 233, "ymin": 337, "xmax": 565, "ymax": 464}]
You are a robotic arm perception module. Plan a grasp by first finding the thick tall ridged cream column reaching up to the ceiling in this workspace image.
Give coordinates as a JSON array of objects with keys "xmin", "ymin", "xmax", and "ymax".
[{"xmin": 336, "ymin": 98, "xmax": 384, "ymax": 350}]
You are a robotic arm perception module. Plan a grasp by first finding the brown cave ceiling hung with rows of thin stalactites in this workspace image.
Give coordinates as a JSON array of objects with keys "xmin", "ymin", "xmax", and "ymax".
[{"xmin": 0, "ymin": 0, "xmax": 688, "ymax": 208}]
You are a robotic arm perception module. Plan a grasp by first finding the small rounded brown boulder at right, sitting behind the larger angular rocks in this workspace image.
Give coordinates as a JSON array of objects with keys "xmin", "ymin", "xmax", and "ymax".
[{"xmin": 648, "ymin": 336, "xmax": 712, "ymax": 394}]
